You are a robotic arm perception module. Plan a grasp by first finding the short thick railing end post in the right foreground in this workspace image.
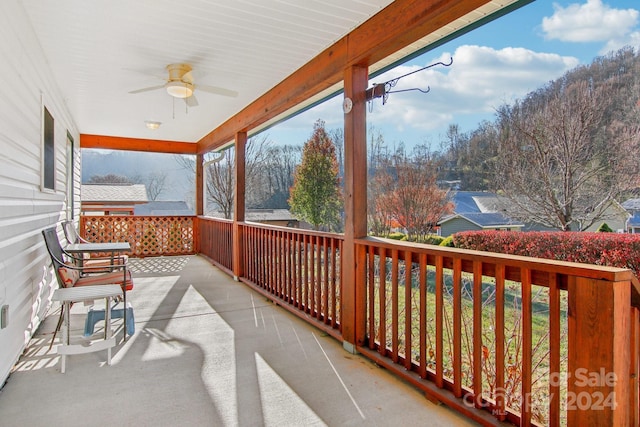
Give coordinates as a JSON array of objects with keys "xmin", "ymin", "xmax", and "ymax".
[{"xmin": 568, "ymin": 278, "xmax": 631, "ymax": 426}]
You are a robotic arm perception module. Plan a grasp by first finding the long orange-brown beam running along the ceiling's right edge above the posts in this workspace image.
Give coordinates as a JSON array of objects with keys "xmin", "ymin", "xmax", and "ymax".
[{"xmin": 197, "ymin": 0, "xmax": 489, "ymax": 153}]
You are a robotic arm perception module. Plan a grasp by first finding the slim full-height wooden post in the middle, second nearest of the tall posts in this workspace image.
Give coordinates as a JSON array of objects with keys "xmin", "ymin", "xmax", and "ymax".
[{"xmin": 233, "ymin": 132, "xmax": 247, "ymax": 280}]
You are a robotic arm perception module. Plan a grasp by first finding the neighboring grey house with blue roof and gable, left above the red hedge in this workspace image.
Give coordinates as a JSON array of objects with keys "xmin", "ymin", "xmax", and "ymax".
[{"xmin": 438, "ymin": 191, "xmax": 524, "ymax": 237}]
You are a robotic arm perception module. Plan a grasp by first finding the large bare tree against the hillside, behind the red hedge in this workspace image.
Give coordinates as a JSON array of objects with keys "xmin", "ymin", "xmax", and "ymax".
[{"xmin": 496, "ymin": 81, "xmax": 639, "ymax": 230}]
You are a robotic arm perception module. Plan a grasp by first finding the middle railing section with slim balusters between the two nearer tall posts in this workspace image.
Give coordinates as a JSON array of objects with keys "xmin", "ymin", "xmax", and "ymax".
[{"xmin": 241, "ymin": 223, "xmax": 343, "ymax": 336}]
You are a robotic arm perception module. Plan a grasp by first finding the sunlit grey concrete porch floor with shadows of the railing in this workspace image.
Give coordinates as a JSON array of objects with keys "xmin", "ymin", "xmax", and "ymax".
[{"xmin": 0, "ymin": 256, "xmax": 473, "ymax": 427}]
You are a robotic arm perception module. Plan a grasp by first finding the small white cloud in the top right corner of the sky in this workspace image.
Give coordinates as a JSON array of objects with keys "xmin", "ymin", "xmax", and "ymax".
[{"xmin": 542, "ymin": 0, "xmax": 640, "ymax": 42}]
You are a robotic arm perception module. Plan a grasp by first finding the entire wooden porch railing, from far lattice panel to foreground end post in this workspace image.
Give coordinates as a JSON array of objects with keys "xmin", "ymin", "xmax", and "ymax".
[{"xmin": 80, "ymin": 217, "xmax": 640, "ymax": 426}]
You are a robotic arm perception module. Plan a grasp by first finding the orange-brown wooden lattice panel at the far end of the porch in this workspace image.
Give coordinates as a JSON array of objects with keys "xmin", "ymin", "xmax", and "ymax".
[{"xmin": 80, "ymin": 216, "xmax": 194, "ymax": 257}]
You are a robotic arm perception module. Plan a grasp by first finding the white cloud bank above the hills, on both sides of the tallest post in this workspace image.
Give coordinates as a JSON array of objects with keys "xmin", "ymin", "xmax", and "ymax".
[{"xmin": 267, "ymin": 45, "xmax": 579, "ymax": 144}]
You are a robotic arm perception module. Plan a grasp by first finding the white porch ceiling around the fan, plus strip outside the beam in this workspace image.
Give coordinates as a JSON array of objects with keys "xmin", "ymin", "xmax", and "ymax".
[{"xmin": 22, "ymin": 0, "xmax": 515, "ymax": 142}]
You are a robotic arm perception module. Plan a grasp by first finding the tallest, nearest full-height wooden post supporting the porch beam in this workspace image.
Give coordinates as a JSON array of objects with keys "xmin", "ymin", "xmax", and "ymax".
[{"xmin": 341, "ymin": 66, "xmax": 368, "ymax": 352}]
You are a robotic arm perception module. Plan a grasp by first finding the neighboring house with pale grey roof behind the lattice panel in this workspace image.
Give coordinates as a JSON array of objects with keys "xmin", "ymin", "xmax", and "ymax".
[{"xmin": 80, "ymin": 184, "xmax": 149, "ymax": 215}]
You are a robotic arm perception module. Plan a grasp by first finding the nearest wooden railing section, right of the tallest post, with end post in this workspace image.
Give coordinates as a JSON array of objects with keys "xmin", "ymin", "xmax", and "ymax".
[{"xmin": 357, "ymin": 238, "xmax": 640, "ymax": 426}]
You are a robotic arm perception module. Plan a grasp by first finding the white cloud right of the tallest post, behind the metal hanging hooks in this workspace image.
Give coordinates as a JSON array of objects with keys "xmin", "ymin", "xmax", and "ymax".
[{"xmin": 369, "ymin": 45, "xmax": 579, "ymax": 131}]
